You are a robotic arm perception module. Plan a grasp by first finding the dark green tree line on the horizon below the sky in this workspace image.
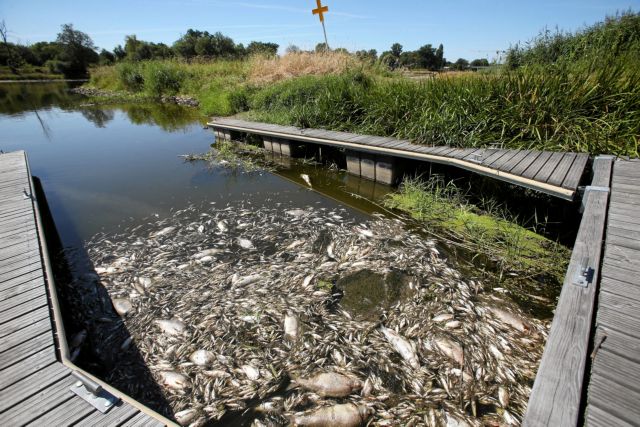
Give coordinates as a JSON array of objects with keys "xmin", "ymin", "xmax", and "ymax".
[{"xmin": 0, "ymin": 21, "xmax": 489, "ymax": 77}]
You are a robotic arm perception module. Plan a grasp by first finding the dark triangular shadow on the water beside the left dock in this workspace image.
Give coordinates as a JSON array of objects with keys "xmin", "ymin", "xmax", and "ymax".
[{"xmin": 33, "ymin": 177, "xmax": 174, "ymax": 419}]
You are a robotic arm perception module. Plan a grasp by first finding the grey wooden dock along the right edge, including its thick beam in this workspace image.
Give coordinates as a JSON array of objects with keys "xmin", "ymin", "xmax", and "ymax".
[{"xmin": 523, "ymin": 156, "xmax": 640, "ymax": 426}]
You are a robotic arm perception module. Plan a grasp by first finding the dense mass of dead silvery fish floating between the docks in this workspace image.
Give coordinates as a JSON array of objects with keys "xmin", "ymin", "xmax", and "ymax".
[{"xmin": 85, "ymin": 204, "xmax": 548, "ymax": 426}]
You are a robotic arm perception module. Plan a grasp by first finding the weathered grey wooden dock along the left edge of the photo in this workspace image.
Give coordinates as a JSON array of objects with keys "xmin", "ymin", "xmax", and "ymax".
[{"xmin": 0, "ymin": 151, "xmax": 170, "ymax": 426}]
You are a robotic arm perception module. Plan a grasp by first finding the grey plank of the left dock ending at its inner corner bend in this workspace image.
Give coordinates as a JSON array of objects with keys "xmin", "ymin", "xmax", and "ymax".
[{"xmin": 0, "ymin": 363, "xmax": 69, "ymax": 412}]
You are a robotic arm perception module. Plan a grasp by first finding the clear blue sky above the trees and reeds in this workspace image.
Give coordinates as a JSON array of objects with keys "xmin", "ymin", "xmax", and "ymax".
[{"xmin": 0, "ymin": 0, "xmax": 640, "ymax": 61}]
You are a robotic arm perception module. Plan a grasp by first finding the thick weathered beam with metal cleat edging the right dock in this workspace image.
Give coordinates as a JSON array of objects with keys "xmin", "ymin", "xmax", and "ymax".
[{"xmin": 523, "ymin": 158, "xmax": 613, "ymax": 426}]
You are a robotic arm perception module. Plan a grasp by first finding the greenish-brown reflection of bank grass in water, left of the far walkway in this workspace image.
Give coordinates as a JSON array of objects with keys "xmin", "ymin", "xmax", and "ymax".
[{"xmin": 119, "ymin": 104, "xmax": 199, "ymax": 132}]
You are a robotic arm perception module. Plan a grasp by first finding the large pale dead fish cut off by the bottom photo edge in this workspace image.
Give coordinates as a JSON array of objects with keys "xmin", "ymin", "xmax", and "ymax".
[{"xmin": 291, "ymin": 403, "xmax": 373, "ymax": 427}]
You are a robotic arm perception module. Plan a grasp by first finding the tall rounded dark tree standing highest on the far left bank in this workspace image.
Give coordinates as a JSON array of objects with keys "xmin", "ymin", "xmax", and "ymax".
[{"xmin": 56, "ymin": 24, "xmax": 98, "ymax": 76}]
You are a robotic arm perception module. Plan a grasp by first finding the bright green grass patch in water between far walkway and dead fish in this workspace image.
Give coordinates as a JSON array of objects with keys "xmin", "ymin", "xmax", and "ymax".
[{"xmin": 385, "ymin": 176, "xmax": 571, "ymax": 298}]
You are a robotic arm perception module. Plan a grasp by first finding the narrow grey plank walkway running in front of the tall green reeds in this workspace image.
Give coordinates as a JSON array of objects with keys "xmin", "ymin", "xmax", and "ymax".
[{"xmin": 208, "ymin": 118, "xmax": 589, "ymax": 200}]
